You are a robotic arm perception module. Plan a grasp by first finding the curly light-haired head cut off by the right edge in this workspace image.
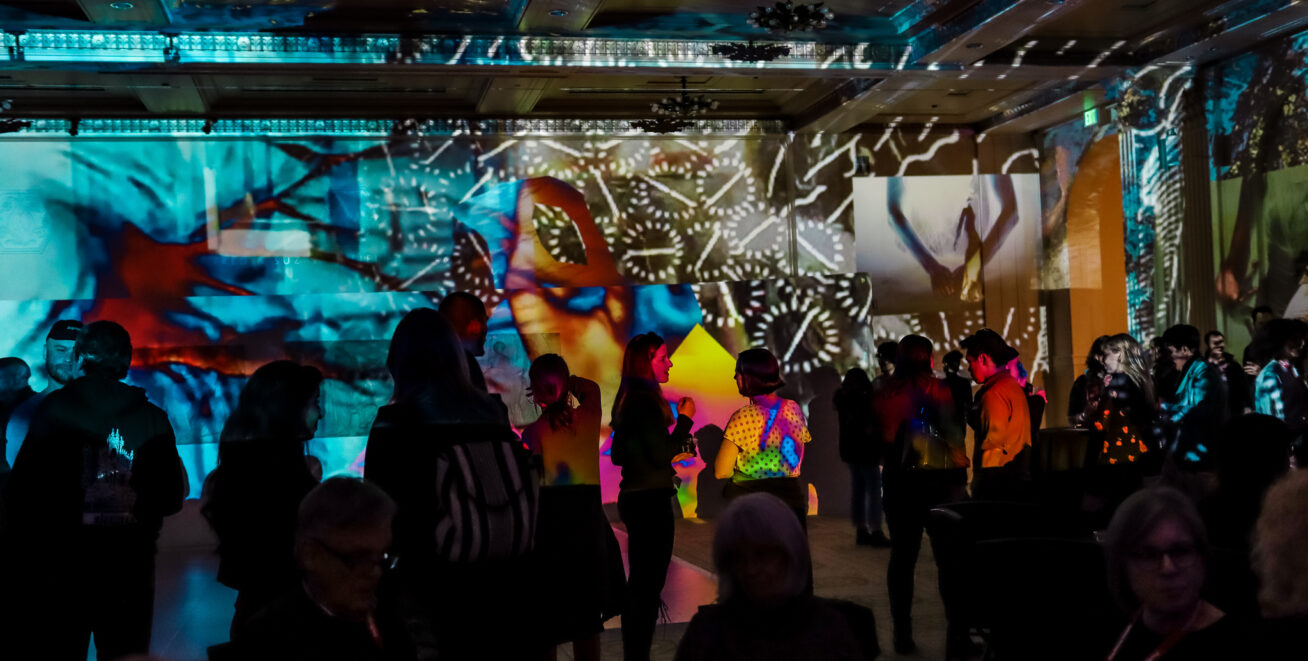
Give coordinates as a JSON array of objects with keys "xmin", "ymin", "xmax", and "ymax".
[{"xmin": 1253, "ymin": 470, "xmax": 1308, "ymax": 618}]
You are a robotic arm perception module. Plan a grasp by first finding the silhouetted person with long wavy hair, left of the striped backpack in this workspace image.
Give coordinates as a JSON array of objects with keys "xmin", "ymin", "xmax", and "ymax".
[{"xmin": 201, "ymin": 360, "xmax": 323, "ymax": 637}]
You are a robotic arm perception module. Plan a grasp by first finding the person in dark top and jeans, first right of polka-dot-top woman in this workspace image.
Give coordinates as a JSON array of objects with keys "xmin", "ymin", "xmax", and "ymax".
[{"xmin": 835, "ymin": 368, "xmax": 891, "ymax": 547}]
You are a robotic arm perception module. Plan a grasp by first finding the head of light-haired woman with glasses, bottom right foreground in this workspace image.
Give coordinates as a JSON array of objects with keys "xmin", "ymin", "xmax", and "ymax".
[{"xmin": 1104, "ymin": 487, "xmax": 1209, "ymax": 619}]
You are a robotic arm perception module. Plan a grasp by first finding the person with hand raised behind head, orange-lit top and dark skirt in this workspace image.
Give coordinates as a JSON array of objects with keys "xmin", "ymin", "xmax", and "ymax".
[{"xmin": 522, "ymin": 353, "xmax": 625, "ymax": 661}]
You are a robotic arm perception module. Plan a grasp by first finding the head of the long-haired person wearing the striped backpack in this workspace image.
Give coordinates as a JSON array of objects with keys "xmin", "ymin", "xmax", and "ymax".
[{"xmin": 386, "ymin": 308, "xmax": 472, "ymax": 402}]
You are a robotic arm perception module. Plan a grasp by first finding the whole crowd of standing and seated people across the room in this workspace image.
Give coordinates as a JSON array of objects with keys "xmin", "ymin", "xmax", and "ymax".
[{"xmin": 0, "ymin": 292, "xmax": 1308, "ymax": 661}]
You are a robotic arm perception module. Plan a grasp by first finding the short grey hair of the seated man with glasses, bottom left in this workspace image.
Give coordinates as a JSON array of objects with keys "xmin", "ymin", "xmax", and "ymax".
[{"xmin": 296, "ymin": 475, "xmax": 396, "ymax": 539}]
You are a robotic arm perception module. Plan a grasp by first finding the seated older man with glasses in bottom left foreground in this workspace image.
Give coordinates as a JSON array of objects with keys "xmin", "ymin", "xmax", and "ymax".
[{"xmin": 230, "ymin": 476, "xmax": 417, "ymax": 661}]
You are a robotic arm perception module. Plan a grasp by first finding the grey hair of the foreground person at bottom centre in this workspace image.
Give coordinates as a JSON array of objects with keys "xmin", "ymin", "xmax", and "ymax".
[{"xmin": 713, "ymin": 493, "xmax": 812, "ymax": 602}]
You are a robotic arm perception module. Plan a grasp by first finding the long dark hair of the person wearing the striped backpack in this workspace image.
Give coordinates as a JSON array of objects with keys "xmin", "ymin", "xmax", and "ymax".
[{"xmin": 386, "ymin": 308, "xmax": 504, "ymax": 423}]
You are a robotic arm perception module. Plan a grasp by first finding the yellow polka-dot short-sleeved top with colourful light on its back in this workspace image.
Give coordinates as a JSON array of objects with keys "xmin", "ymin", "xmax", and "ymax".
[{"xmin": 714, "ymin": 398, "xmax": 812, "ymax": 482}]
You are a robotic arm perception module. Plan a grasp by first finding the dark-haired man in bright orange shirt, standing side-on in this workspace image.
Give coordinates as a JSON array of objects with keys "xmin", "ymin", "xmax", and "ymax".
[{"xmin": 961, "ymin": 329, "xmax": 1031, "ymax": 500}]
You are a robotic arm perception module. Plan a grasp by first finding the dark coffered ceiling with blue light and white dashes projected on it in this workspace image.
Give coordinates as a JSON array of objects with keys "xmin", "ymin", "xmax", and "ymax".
[{"xmin": 0, "ymin": 0, "xmax": 1308, "ymax": 131}]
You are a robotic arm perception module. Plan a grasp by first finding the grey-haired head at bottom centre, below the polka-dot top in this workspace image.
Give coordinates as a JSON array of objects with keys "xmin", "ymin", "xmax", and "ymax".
[{"xmin": 713, "ymin": 493, "xmax": 811, "ymax": 605}]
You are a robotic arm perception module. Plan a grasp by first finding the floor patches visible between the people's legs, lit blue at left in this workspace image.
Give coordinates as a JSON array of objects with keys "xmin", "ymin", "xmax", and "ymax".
[{"xmin": 104, "ymin": 517, "xmax": 944, "ymax": 661}]
